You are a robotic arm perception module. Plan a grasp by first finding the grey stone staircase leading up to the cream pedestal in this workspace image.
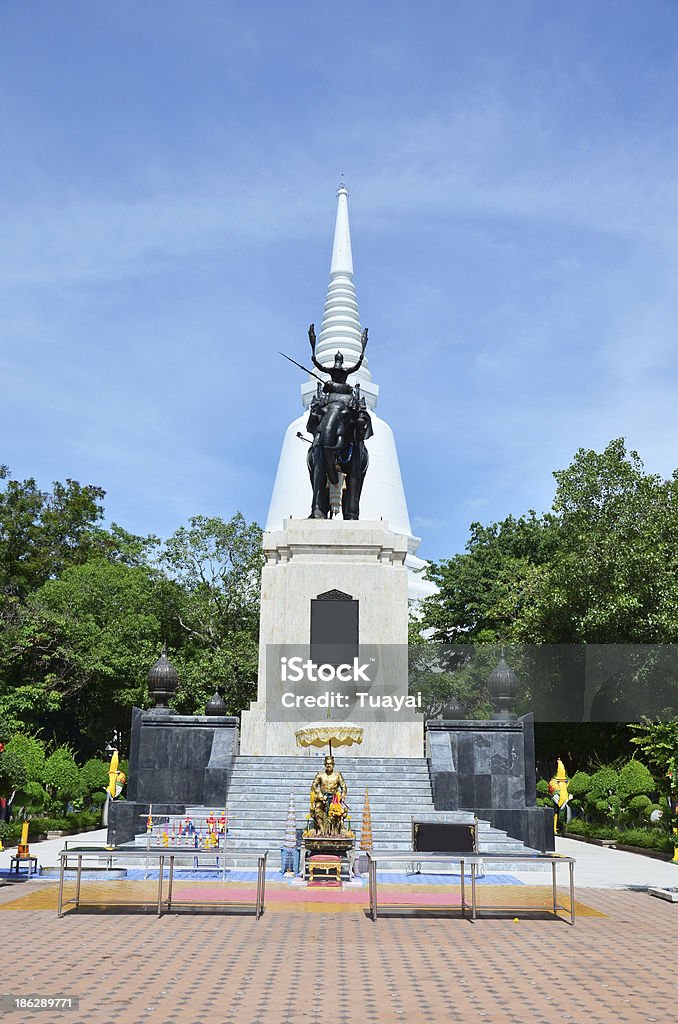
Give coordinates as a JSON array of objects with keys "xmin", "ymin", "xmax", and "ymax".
[{"xmin": 178, "ymin": 754, "xmax": 529, "ymax": 867}]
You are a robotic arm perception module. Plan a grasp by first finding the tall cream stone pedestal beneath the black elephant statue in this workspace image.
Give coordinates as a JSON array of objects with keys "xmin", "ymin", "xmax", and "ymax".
[{"xmin": 241, "ymin": 519, "xmax": 423, "ymax": 758}]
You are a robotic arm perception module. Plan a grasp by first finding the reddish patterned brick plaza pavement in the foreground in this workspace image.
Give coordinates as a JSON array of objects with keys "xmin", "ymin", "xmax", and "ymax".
[{"xmin": 0, "ymin": 882, "xmax": 678, "ymax": 1024}]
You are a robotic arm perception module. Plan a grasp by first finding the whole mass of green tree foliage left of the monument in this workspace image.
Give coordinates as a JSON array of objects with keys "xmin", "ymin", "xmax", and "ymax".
[{"xmin": 0, "ymin": 467, "xmax": 261, "ymax": 753}]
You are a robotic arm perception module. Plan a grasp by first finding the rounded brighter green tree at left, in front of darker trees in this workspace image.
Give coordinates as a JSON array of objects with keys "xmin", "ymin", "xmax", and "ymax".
[{"xmin": 0, "ymin": 558, "xmax": 175, "ymax": 755}]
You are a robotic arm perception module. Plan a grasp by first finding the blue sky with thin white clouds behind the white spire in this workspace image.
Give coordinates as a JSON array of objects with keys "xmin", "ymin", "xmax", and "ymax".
[{"xmin": 0, "ymin": 0, "xmax": 678, "ymax": 558}]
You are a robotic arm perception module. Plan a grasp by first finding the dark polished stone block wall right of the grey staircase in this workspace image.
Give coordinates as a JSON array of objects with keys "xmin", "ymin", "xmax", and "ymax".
[{"xmin": 426, "ymin": 715, "xmax": 554, "ymax": 852}]
